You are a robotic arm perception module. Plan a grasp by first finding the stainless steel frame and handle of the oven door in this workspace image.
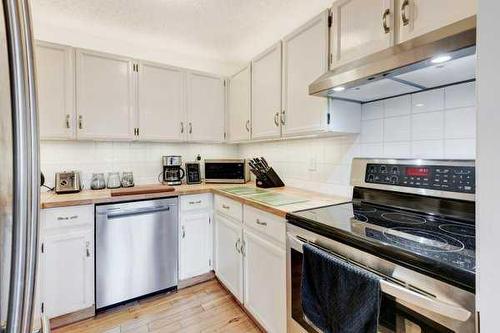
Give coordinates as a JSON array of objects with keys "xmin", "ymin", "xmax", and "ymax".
[{"xmin": 286, "ymin": 223, "xmax": 475, "ymax": 333}]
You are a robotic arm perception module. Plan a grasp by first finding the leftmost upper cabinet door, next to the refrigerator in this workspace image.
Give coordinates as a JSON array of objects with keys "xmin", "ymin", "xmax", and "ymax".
[{"xmin": 35, "ymin": 42, "xmax": 76, "ymax": 139}]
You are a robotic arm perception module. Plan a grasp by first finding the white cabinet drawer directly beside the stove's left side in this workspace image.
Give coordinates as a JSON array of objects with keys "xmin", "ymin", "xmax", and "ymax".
[{"xmin": 243, "ymin": 205, "xmax": 286, "ymax": 244}]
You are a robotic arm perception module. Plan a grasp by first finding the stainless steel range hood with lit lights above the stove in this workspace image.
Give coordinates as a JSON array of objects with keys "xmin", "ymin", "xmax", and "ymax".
[{"xmin": 309, "ymin": 16, "xmax": 476, "ymax": 103}]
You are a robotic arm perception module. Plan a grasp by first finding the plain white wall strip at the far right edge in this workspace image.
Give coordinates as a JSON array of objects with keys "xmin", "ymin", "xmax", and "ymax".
[{"xmin": 476, "ymin": 0, "xmax": 500, "ymax": 326}]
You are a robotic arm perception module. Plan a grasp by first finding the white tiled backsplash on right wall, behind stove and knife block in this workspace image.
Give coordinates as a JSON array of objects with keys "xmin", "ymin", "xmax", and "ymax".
[{"xmin": 239, "ymin": 83, "xmax": 476, "ymax": 196}]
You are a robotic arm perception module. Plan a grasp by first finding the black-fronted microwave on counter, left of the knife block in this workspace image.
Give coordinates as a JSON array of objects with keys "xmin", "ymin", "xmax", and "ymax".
[{"xmin": 205, "ymin": 158, "xmax": 250, "ymax": 184}]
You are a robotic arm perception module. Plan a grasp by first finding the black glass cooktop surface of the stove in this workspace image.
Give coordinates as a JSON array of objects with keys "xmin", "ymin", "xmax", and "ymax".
[{"xmin": 292, "ymin": 202, "xmax": 476, "ymax": 272}]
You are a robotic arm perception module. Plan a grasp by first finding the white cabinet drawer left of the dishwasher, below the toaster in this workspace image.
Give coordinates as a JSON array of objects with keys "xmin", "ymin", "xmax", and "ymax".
[{"xmin": 41, "ymin": 205, "xmax": 94, "ymax": 229}]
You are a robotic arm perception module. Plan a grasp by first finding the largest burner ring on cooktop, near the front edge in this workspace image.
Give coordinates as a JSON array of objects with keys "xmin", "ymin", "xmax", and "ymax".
[{"xmin": 383, "ymin": 227, "xmax": 465, "ymax": 252}]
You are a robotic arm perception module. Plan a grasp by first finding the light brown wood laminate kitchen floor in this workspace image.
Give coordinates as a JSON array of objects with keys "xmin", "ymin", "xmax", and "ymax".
[{"xmin": 54, "ymin": 280, "xmax": 261, "ymax": 333}]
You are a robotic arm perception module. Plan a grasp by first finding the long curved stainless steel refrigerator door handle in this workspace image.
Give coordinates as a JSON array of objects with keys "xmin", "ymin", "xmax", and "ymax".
[{"xmin": 3, "ymin": 0, "xmax": 40, "ymax": 333}]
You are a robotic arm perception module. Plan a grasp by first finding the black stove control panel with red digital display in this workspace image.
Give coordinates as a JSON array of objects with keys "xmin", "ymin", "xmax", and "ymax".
[{"xmin": 365, "ymin": 163, "xmax": 476, "ymax": 193}]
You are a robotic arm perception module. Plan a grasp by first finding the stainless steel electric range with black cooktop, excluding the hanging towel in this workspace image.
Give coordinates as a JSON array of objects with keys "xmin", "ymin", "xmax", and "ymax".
[{"xmin": 287, "ymin": 159, "xmax": 476, "ymax": 332}]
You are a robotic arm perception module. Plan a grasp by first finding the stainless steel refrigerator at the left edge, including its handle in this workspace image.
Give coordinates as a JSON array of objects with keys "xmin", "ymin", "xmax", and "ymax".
[{"xmin": 0, "ymin": 0, "xmax": 47, "ymax": 333}]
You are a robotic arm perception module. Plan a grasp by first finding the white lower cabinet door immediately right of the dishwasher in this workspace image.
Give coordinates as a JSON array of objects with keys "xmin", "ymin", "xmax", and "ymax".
[{"xmin": 179, "ymin": 212, "xmax": 212, "ymax": 280}]
